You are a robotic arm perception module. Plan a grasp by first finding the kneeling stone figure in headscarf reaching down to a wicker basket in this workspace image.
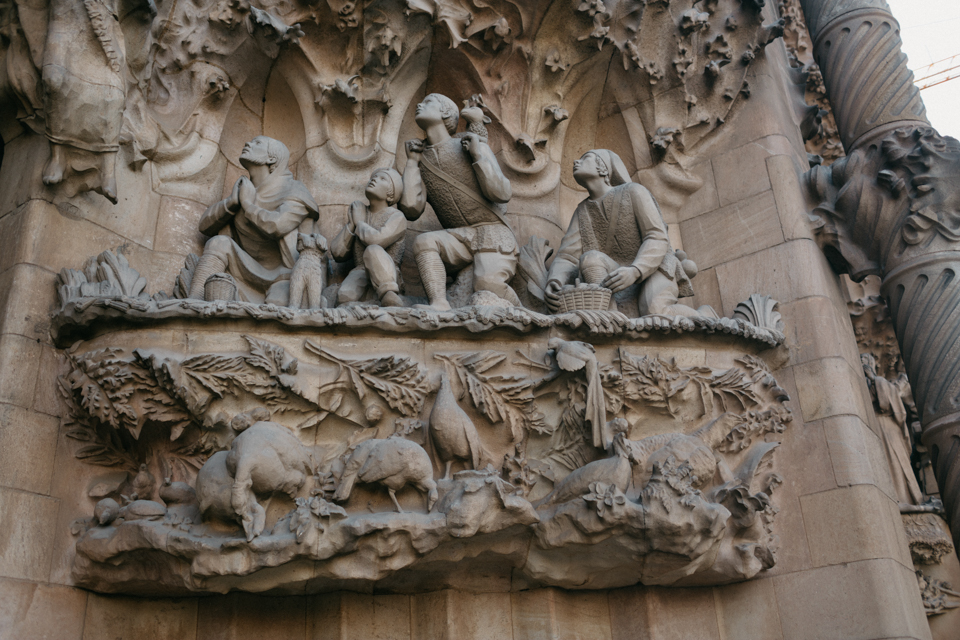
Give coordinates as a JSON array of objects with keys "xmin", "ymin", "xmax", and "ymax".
[{"xmin": 545, "ymin": 149, "xmax": 716, "ymax": 317}]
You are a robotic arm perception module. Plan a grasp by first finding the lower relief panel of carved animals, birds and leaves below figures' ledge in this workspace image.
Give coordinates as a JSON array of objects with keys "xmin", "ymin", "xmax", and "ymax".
[{"xmin": 61, "ymin": 336, "xmax": 791, "ymax": 593}]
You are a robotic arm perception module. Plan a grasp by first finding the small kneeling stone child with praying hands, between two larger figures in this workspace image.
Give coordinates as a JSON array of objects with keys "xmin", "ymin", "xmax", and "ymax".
[{"xmin": 330, "ymin": 168, "xmax": 407, "ymax": 307}]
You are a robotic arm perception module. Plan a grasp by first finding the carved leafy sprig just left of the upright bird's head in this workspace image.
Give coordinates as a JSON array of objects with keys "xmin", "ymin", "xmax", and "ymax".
[{"xmin": 304, "ymin": 340, "xmax": 427, "ymax": 418}]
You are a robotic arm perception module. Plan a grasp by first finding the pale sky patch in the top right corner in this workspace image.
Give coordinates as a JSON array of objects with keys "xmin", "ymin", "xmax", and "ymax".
[{"xmin": 887, "ymin": 0, "xmax": 960, "ymax": 138}]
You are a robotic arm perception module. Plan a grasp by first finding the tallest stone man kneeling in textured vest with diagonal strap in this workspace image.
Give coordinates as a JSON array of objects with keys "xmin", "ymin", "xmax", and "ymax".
[{"xmin": 400, "ymin": 93, "xmax": 519, "ymax": 309}]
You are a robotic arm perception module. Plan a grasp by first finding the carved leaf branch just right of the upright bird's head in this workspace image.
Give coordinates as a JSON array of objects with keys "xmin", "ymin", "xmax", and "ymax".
[{"xmin": 434, "ymin": 351, "xmax": 550, "ymax": 442}]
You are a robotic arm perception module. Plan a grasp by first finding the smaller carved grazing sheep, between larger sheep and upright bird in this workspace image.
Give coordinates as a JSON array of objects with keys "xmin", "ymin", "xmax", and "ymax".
[{"xmin": 333, "ymin": 437, "xmax": 438, "ymax": 513}]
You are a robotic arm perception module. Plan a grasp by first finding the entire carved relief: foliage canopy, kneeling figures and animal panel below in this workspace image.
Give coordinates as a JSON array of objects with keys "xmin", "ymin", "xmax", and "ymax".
[{"xmin": 13, "ymin": 0, "xmax": 808, "ymax": 594}]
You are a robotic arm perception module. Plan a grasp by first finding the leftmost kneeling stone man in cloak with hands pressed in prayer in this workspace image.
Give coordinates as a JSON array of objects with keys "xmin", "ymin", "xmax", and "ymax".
[{"xmin": 189, "ymin": 136, "xmax": 319, "ymax": 305}]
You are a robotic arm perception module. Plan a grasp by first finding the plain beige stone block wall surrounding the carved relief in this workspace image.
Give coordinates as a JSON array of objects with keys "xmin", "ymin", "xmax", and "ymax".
[{"xmin": 0, "ymin": 1, "xmax": 930, "ymax": 640}]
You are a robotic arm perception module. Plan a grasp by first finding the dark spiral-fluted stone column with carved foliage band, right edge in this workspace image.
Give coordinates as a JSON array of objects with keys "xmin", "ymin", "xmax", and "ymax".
[{"xmin": 802, "ymin": 0, "xmax": 960, "ymax": 543}]
